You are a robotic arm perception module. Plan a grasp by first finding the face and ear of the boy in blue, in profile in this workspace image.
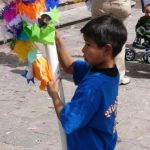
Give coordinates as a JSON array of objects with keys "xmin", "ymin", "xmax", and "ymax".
[{"xmin": 82, "ymin": 36, "xmax": 111, "ymax": 66}]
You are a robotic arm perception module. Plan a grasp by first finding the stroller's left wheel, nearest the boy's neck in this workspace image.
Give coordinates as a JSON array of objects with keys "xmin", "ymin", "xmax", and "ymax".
[{"xmin": 125, "ymin": 48, "xmax": 135, "ymax": 61}]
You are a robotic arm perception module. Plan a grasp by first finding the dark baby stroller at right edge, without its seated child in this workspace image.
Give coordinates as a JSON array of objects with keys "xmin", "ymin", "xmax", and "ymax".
[{"xmin": 125, "ymin": 0, "xmax": 150, "ymax": 63}]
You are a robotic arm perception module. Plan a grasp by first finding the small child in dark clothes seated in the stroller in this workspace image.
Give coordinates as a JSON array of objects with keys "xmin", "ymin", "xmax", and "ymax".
[{"xmin": 133, "ymin": 4, "xmax": 150, "ymax": 48}]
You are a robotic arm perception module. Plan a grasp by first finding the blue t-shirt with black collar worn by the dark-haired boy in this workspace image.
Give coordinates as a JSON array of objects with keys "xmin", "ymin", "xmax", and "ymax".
[{"xmin": 60, "ymin": 61, "xmax": 119, "ymax": 150}]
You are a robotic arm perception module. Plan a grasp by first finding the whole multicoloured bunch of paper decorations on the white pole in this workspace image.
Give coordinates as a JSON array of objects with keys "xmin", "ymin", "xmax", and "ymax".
[{"xmin": 0, "ymin": 0, "xmax": 60, "ymax": 90}]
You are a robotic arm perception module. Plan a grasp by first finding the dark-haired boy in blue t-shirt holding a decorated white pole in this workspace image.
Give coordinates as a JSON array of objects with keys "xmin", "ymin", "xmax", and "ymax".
[{"xmin": 48, "ymin": 15, "xmax": 127, "ymax": 150}]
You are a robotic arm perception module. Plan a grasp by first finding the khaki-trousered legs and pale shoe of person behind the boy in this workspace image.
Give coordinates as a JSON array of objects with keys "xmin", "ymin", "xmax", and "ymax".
[{"xmin": 91, "ymin": 0, "xmax": 131, "ymax": 84}]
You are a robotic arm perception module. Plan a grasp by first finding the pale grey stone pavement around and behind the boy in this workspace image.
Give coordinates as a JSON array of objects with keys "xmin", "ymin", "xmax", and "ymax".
[{"xmin": 0, "ymin": 2, "xmax": 150, "ymax": 150}]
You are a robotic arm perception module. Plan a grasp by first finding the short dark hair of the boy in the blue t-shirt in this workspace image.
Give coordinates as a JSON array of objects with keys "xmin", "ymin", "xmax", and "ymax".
[{"xmin": 80, "ymin": 15, "xmax": 127, "ymax": 57}]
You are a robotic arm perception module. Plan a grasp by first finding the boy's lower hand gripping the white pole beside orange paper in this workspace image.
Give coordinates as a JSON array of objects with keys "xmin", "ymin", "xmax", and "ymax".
[{"xmin": 47, "ymin": 78, "xmax": 61, "ymax": 99}]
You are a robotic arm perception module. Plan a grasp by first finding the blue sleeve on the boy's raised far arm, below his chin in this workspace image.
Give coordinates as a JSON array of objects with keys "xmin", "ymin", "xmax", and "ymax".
[{"xmin": 73, "ymin": 60, "xmax": 90, "ymax": 85}]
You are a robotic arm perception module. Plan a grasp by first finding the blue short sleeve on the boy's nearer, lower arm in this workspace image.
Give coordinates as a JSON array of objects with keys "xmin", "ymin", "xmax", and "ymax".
[{"xmin": 60, "ymin": 87, "xmax": 98, "ymax": 134}]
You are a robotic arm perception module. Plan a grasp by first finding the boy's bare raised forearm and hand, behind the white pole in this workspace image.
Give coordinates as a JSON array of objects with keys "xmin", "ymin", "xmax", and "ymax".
[{"xmin": 55, "ymin": 32, "xmax": 73, "ymax": 74}]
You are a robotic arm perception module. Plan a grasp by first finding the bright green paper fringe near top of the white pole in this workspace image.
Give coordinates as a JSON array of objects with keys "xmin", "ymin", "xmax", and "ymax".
[{"xmin": 23, "ymin": 8, "xmax": 59, "ymax": 45}]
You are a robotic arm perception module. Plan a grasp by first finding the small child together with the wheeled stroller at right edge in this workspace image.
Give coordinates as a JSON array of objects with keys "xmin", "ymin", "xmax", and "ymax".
[{"xmin": 125, "ymin": 3, "xmax": 150, "ymax": 63}]
